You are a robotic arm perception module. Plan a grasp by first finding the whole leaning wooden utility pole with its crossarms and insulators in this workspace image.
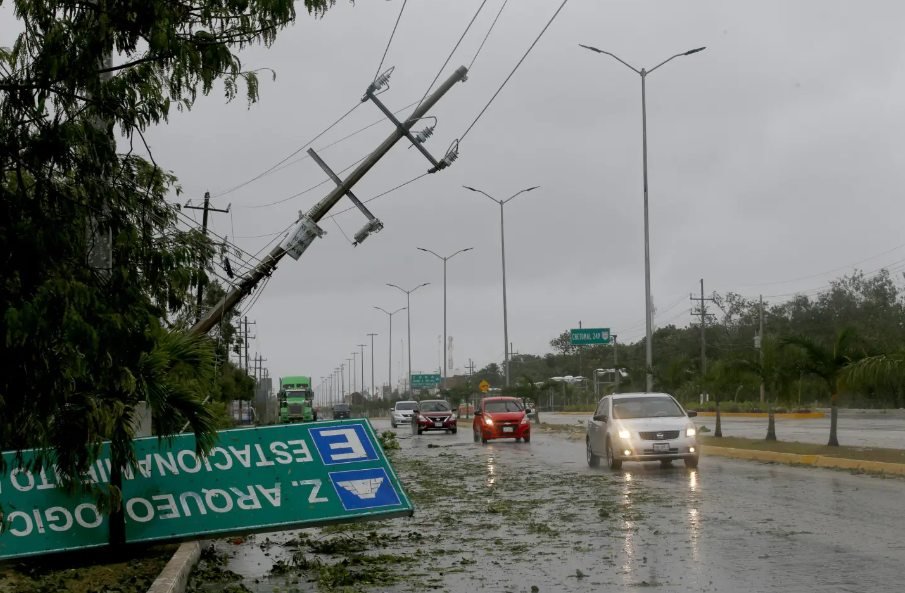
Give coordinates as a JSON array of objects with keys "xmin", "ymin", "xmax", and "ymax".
[{"xmin": 191, "ymin": 66, "xmax": 468, "ymax": 334}]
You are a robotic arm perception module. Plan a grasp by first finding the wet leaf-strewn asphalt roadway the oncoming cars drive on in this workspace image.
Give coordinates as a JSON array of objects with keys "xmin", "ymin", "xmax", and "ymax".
[{"xmin": 218, "ymin": 420, "xmax": 905, "ymax": 593}]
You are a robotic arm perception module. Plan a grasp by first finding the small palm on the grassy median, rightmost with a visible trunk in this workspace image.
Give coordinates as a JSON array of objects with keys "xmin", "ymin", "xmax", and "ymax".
[{"xmin": 784, "ymin": 328, "xmax": 863, "ymax": 447}]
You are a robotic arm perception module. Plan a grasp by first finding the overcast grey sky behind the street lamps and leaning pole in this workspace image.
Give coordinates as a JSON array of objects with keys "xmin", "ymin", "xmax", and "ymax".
[{"xmin": 5, "ymin": 0, "xmax": 905, "ymax": 398}]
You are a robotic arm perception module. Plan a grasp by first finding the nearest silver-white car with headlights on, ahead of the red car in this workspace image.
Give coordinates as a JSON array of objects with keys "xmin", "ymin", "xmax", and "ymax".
[{"xmin": 585, "ymin": 393, "xmax": 700, "ymax": 469}]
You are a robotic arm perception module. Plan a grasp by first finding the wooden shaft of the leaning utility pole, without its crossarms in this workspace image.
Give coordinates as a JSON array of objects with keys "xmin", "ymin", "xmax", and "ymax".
[{"xmin": 190, "ymin": 66, "xmax": 468, "ymax": 334}]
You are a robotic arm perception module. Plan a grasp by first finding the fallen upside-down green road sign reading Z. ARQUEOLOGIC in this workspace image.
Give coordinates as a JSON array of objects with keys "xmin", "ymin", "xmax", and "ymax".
[{"xmin": 0, "ymin": 419, "xmax": 413, "ymax": 558}]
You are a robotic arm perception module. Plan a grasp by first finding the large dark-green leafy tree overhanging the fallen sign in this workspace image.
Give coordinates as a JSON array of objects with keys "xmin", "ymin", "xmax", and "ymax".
[{"xmin": 0, "ymin": 0, "xmax": 333, "ymax": 502}]
